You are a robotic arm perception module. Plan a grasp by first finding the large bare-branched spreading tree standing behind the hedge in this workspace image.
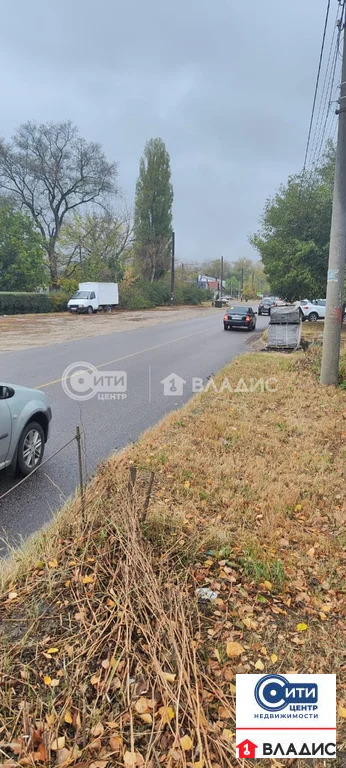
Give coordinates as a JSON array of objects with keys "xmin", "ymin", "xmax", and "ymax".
[{"xmin": 0, "ymin": 121, "xmax": 117, "ymax": 287}]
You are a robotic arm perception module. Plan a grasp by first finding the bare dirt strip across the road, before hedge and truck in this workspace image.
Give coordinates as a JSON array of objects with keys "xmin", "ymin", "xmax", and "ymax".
[{"xmin": 0, "ymin": 306, "xmax": 218, "ymax": 352}]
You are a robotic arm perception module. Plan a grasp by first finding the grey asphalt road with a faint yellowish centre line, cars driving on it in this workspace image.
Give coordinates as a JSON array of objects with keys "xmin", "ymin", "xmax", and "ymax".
[{"xmin": 0, "ymin": 310, "xmax": 268, "ymax": 551}]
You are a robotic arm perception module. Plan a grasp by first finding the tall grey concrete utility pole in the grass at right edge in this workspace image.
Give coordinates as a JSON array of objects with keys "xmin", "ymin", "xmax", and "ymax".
[{"xmin": 321, "ymin": 18, "xmax": 346, "ymax": 386}]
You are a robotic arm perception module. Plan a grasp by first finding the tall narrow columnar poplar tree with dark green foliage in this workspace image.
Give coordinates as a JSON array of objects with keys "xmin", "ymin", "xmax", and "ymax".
[{"xmin": 134, "ymin": 138, "xmax": 173, "ymax": 282}]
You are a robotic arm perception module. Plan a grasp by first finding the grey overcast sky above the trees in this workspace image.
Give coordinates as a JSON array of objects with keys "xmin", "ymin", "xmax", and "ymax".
[{"xmin": 0, "ymin": 0, "xmax": 330, "ymax": 262}]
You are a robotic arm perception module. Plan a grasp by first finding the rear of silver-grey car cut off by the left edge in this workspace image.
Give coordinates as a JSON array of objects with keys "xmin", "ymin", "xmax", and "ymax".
[{"xmin": 0, "ymin": 382, "xmax": 52, "ymax": 475}]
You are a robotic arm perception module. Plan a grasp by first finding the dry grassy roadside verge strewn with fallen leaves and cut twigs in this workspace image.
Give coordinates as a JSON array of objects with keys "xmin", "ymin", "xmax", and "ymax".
[{"xmin": 0, "ymin": 338, "xmax": 346, "ymax": 768}]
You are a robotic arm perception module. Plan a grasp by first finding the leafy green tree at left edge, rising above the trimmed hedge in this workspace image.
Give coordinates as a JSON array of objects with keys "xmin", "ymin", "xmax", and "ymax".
[{"xmin": 0, "ymin": 198, "xmax": 48, "ymax": 291}]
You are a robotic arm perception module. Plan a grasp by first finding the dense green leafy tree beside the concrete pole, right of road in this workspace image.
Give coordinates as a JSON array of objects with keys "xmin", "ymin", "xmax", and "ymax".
[{"xmin": 251, "ymin": 144, "xmax": 335, "ymax": 301}]
